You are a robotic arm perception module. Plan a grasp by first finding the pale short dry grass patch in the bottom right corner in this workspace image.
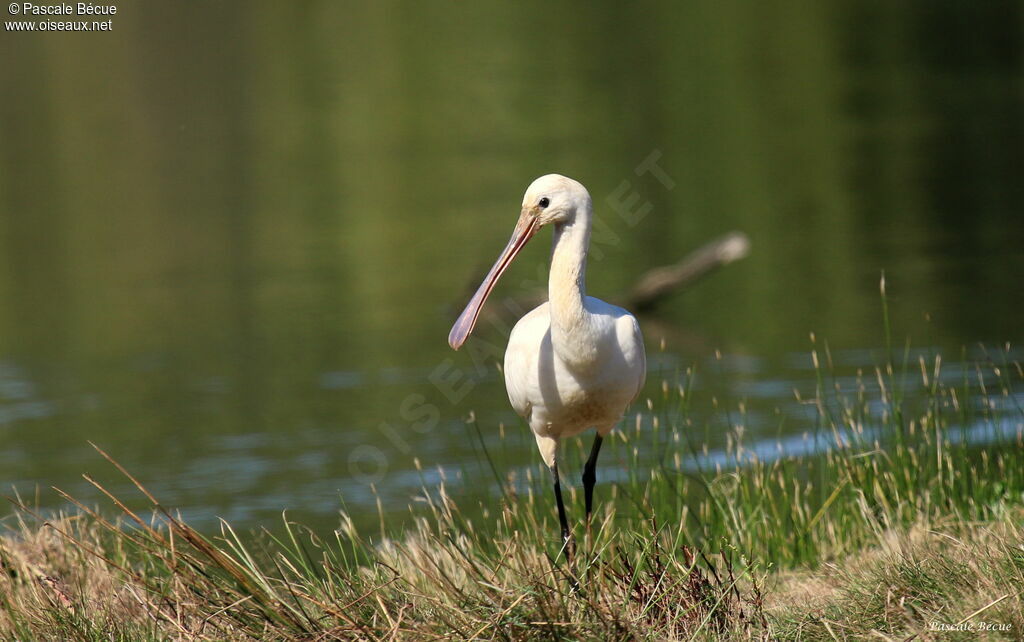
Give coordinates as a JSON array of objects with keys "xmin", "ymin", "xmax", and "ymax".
[{"xmin": 766, "ymin": 518, "xmax": 1024, "ymax": 640}]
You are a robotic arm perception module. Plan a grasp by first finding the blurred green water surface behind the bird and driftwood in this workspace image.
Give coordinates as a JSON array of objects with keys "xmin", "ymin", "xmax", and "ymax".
[{"xmin": 0, "ymin": 0, "xmax": 1024, "ymax": 527}]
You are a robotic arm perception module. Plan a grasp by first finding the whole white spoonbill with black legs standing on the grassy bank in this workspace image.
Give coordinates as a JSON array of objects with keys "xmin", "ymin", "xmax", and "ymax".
[{"xmin": 449, "ymin": 174, "xmax": 646, "ymax": 551}]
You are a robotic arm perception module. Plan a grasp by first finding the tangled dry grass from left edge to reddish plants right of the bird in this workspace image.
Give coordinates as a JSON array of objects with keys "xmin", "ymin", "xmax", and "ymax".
[{"xmin": 0, "ymin": 475, "xmax": 767, "ymax": 640}]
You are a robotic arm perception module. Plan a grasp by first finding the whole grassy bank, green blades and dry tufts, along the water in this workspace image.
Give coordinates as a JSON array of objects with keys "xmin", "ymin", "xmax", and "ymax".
[{"xmin": 0, "ymin": 311, "xmax": 1024, "ymax": 640}]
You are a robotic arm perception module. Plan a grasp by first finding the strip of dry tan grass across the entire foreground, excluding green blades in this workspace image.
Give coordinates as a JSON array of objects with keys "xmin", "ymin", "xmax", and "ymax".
[{"xmin": 0, "ymin": 491, "xmax": 1024, "ymax": 640}]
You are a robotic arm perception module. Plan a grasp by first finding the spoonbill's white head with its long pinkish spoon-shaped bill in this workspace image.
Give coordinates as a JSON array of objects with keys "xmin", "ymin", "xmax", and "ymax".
[{"xmin": 449, "ymin": 174, "xmax": 591, "ymax": 350}]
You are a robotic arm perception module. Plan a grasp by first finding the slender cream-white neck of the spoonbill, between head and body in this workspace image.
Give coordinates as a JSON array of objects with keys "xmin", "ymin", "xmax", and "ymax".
[{"xmin": 548, "ymin": 204, "xmax": 594, "ymax": 365}]
